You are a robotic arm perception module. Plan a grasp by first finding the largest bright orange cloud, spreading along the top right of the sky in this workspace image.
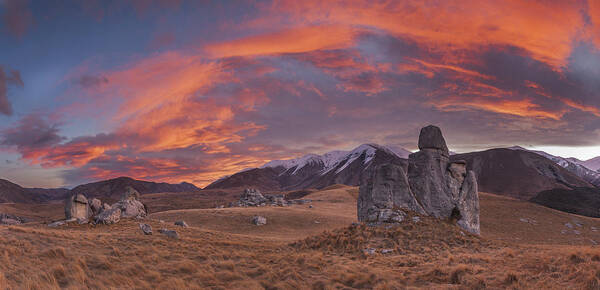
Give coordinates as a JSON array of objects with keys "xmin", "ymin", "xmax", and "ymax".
[{"xmin": 272, "ymin": 0, "xmax": 593, "ymax": 66}]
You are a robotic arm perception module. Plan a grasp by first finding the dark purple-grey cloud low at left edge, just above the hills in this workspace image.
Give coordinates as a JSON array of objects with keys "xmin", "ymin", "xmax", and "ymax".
[{"xmin": 0, "ymin": 114, "xmax": 65, "ymax": 152}]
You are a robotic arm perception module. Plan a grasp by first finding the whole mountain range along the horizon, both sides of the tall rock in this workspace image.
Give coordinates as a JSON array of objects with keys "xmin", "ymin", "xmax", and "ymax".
[{"xmin": 0, "ymin": 144, "xmax": 600, "ymax": 216}]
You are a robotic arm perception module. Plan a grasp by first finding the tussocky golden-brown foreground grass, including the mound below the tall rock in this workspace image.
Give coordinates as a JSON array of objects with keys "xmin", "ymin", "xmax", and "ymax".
[{"xmin": 0, "ymin": 218, "xmax": 600, "ymax": 289}]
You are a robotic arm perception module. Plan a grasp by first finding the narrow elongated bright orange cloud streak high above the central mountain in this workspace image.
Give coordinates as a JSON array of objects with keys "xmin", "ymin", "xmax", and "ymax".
[{"xmin": 205, "ymin": 25, "xmax": 357, "ymax": 57}]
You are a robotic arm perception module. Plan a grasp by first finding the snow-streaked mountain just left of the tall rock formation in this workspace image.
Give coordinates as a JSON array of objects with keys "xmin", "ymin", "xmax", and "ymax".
[{"xmin": 207, "ymin": 144, "xmax": 411, "ymax": 190}]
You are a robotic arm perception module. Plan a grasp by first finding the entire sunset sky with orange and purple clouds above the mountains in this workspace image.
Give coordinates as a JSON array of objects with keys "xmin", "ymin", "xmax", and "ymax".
[{"xmin": 0, "ymin": 0, "xmax": 600, "ymax": 187}]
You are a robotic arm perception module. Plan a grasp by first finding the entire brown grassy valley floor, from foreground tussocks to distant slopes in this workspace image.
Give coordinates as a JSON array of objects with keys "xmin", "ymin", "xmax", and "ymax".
[{"xmin": 0, "ymin": 186, "xmax": 600, "ymax": 289}]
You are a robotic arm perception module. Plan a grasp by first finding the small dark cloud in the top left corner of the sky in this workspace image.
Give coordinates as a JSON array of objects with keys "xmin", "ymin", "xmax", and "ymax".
[{"xmin": 0, "ymin": 0, "xmax": 33, "ymax": 38}]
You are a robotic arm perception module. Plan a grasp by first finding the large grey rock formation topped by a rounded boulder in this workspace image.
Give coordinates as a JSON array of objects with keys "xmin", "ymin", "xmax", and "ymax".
[{"xmin": 358, "ymin": 126, "xmax": 479, "ymax": 234}]
